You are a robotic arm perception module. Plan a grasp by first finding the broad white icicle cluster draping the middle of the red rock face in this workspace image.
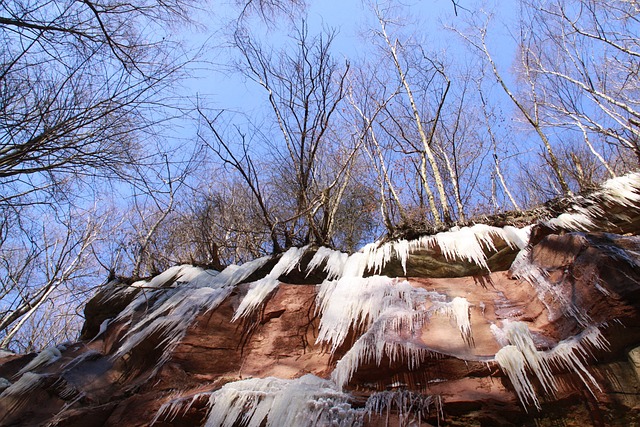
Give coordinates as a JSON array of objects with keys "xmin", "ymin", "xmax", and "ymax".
[{"xmin": 317, "ymin": 276, "xmax": 471, "ymax": 387}]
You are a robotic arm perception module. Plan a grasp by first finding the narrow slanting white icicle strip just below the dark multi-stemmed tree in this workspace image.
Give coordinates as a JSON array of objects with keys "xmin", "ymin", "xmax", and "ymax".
[{"xmin": 231, "ymin": 246, "xmax": 308, "ymax": 322}]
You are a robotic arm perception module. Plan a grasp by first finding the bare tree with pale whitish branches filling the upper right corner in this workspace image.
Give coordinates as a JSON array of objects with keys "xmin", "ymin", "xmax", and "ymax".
[{"xmin": 522, "ymin": 0, "xmax": 640, "ymax": 170}]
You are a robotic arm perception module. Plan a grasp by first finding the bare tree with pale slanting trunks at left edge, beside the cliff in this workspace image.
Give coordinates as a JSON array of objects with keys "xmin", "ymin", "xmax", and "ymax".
[{"xmin": 0, "ymin": 206, "xmax": 104, "ymax": 350}]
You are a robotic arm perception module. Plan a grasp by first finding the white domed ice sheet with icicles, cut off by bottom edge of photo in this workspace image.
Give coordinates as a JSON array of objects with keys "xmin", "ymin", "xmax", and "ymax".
[{"xmin": 205, "ymin": 374, "xmax": 364, "ymax": 427}]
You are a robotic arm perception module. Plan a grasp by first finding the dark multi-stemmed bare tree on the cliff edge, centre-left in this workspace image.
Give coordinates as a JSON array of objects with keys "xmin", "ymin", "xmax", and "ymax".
[{"xmin": 201, "ymin": 21, "xmax": 358, "ymax": 251}]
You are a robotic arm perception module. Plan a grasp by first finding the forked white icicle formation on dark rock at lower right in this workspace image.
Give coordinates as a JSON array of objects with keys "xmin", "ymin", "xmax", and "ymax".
[{"xmin": 492, "ymin": 321, "xmax": 608, "ymax": 409}]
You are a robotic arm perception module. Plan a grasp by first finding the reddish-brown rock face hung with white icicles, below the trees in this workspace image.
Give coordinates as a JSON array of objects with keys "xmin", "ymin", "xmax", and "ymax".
[{"xmin": 0, "ymin": 175, "xmax": 640, "ymax": 427}]
